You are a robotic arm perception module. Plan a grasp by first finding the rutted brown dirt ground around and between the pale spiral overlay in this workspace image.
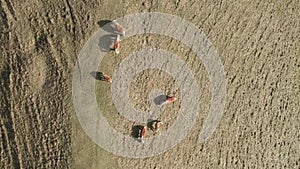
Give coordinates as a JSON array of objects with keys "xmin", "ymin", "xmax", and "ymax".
[{"xmin": 0, "ymin": 0, "xmax": 300, "ymax": 169}]
